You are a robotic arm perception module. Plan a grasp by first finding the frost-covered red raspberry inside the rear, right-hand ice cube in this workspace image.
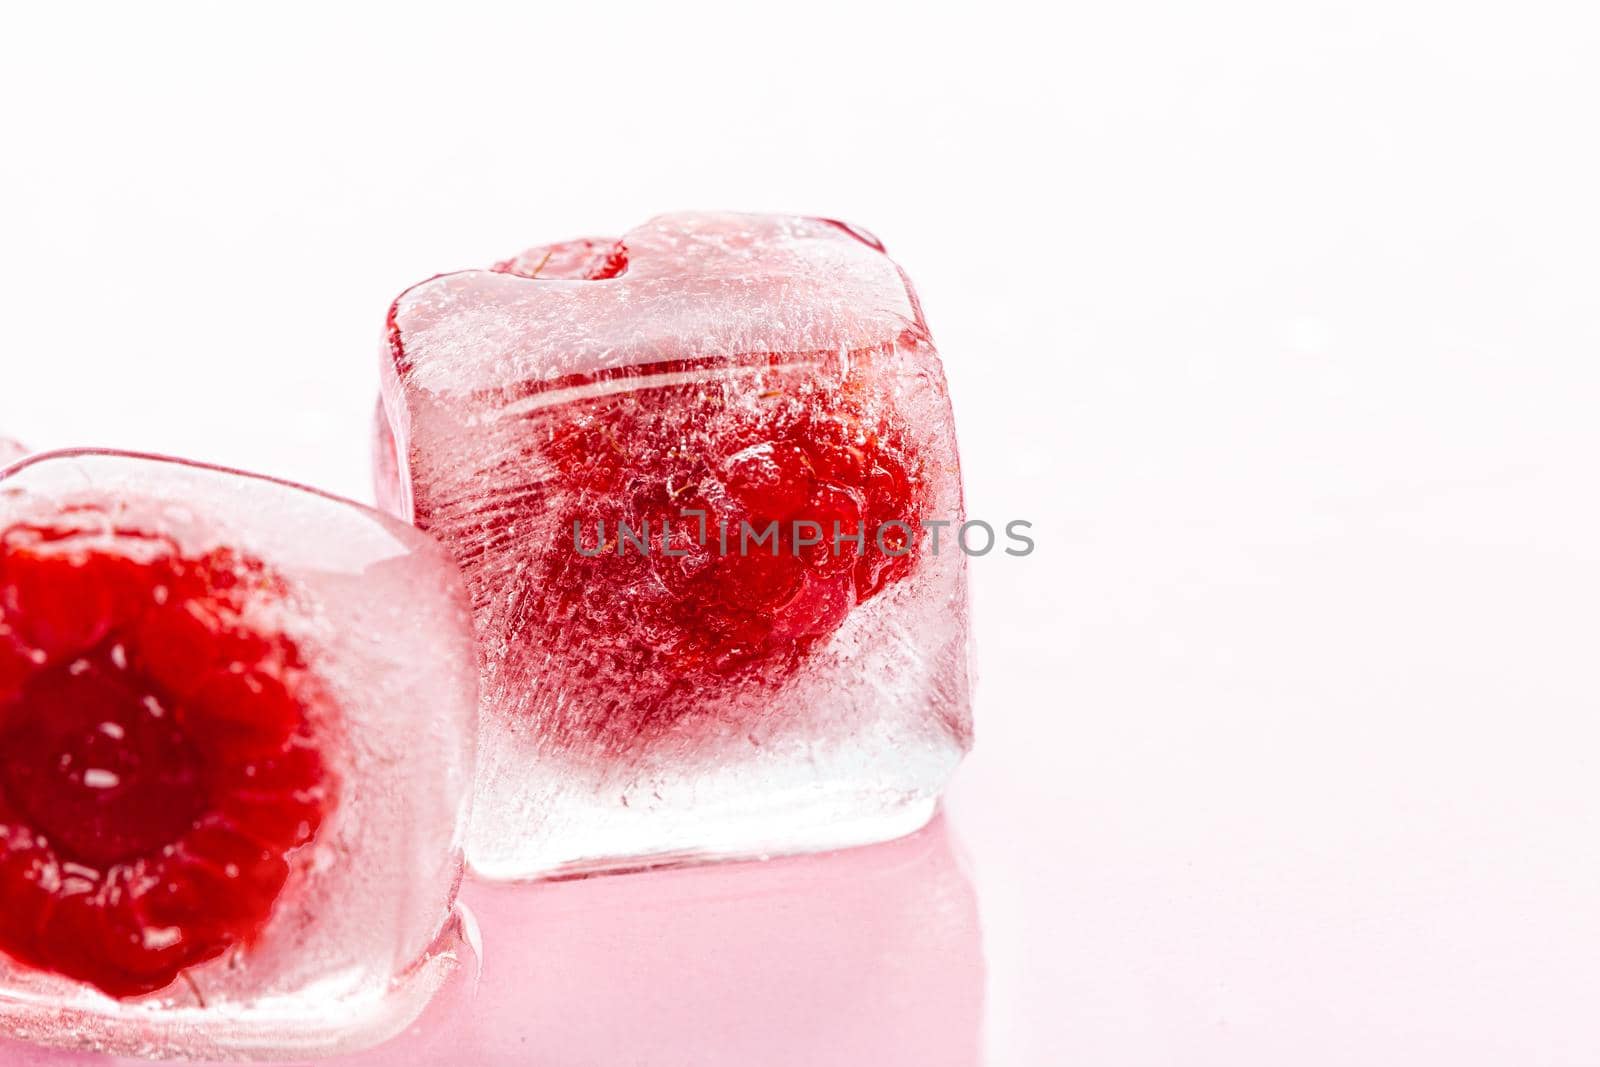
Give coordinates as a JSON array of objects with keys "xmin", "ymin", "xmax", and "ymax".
[{"xmin": 518, "ymin": 355, "xmax": 923, "ymax": 736}]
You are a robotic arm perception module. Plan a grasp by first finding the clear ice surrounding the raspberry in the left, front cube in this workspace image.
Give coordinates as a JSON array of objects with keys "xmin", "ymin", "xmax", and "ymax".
[{"xmin": 0, "ymin": 451, "xmax": 477, "ymax": 1059}]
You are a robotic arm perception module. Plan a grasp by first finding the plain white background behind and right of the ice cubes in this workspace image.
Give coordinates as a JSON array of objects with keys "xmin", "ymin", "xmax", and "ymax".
[{"xmin": 0, "ymin": 2, "xmax": 1600, "ymax": 1067}]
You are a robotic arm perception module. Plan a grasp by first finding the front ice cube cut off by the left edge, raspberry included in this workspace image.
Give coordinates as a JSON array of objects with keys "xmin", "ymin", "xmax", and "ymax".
[{"xmin": 0, "ymin": 451, "xmax": 477, "ymax": 1059}]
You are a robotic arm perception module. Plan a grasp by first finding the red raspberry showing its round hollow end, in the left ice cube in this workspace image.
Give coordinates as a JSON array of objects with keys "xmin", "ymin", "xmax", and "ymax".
[{"xmin": 0, "ymin": 510, "xmax": 334, "ymax": 997}]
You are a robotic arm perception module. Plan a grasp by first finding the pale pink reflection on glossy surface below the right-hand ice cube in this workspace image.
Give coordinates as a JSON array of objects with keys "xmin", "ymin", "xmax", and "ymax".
[{"xmin": 0, "ymin": 816, "xmax": 984, "ymax": 1067}]
